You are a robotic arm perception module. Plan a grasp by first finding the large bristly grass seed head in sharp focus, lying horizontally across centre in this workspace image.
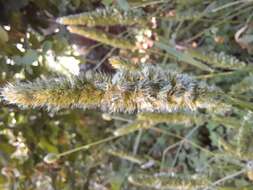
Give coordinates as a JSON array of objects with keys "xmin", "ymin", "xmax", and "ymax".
[{"xmin": 2, "ymin": 64, "xmax": 222, "ymax": 113}]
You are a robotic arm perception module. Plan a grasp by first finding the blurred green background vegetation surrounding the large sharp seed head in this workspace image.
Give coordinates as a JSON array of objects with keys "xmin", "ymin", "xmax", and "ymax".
[{"xmin": 0, "ymin": 0, "xmax": 253, "ymax": 190}]
